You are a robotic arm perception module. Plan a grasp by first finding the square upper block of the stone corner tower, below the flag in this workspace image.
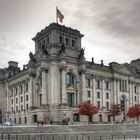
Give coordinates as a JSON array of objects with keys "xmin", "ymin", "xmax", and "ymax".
[{"xmin": 33, "ymin": 23, "xmax": 83, "ymax": 58}]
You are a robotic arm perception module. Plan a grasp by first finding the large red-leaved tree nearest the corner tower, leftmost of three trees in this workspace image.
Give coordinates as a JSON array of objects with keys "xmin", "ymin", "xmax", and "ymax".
[{"xmin": 79, "ymin": 101, "xmax": 99, "ymax": 122}]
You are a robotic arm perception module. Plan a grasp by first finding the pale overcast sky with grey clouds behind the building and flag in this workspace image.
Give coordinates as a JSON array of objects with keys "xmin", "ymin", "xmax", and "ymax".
[{"xmin": 0, "ymin": 0, "xmax": 140, "ymax": 68}]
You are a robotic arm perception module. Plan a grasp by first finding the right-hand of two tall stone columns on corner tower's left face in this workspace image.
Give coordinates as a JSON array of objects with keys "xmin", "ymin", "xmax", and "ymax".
[{"xmin": 41, "ymin": 67, "xmax": 48, "ymax": 105}]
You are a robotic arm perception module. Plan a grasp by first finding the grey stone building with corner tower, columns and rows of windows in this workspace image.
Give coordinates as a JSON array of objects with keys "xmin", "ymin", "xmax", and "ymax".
[{"xmin": 0, "ymin": 23, "xmax": 140, "ymax": 124}]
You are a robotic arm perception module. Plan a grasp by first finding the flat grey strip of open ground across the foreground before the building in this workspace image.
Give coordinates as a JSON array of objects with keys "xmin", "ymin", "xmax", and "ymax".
[{"xmin": 0, "ymin": 124, "xmax": 140, "ymax": 140}]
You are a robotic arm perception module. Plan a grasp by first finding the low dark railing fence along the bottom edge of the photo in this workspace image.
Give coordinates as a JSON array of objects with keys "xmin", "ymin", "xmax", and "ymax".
[{"xmin": 0, "ymin": 133, "xmax": 140, "ymax": 140}]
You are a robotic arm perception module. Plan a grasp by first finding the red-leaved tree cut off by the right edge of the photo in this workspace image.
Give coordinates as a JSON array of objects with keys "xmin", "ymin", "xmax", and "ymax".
[{"xmin": 127, "ymin": 104, "xmax": 140, "ymax": 122}]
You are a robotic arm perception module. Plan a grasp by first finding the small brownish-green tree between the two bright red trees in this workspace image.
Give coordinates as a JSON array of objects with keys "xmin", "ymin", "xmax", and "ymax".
[{"xmin": 109, "ymin": 104, "xmax": 121, "ymax": 122}]
